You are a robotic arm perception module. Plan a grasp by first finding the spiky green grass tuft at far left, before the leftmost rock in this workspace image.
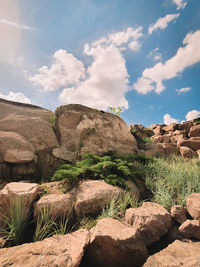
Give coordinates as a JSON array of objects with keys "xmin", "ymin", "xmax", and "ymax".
[{"xmin": 0, "ymin": 198, "xmax": 29, "ymax": 245}]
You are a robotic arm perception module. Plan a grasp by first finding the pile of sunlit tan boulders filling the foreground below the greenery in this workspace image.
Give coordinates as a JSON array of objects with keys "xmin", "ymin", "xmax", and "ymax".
[{"xmin": 0, "ymin": 180, "xmax": 200, "ymax": 267}]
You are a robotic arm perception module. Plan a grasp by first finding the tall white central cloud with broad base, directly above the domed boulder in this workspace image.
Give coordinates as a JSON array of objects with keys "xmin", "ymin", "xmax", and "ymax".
[{"xmin": 59, "ymin": 45, "xmax": 129, "ymax": 110}]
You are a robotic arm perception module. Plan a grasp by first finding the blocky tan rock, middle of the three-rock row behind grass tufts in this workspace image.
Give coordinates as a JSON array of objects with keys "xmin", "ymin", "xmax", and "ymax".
[{"xmin": 34, "ymin": 193, "xmax": 74, "ymax": 219}]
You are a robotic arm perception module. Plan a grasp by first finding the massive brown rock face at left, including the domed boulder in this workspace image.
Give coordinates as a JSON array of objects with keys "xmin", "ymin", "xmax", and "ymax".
[{"xmin": 0, "ymin": 99, "xmax": 138, "ymax": 180}]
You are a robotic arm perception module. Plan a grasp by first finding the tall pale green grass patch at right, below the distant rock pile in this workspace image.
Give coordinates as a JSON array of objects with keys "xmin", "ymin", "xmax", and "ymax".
[{"xmin": 145, "ymin": 155, "xmax": 200, "ymax": 209}]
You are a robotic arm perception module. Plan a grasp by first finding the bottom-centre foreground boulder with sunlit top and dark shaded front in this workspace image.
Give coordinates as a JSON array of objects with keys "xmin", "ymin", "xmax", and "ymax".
[{"xmin": 85, "ymin": 218, "xmax": 148, "ymax": 267}]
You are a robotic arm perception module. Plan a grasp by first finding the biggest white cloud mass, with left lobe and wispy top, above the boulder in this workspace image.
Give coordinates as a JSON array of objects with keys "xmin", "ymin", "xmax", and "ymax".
[{"xmin": 29, "ymin": 27, "xmax": 143, "ymax": 110}]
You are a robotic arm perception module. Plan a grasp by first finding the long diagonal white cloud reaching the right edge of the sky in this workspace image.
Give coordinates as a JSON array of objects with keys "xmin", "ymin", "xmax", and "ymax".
[{"xmin": 133, "ymin": 30, "xmax": 200, "ymax": 94}]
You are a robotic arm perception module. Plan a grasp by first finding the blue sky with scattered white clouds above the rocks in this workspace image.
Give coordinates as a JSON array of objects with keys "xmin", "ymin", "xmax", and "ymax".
[{"xmin": 0, "ymin": 0, "xmax": 200, "ymax": 127}]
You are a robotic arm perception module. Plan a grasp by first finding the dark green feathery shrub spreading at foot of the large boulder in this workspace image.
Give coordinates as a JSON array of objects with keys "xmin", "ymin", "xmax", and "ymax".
[{"xmin": 51, "ymin": 153, "xmax": 151, "ymax": 189}]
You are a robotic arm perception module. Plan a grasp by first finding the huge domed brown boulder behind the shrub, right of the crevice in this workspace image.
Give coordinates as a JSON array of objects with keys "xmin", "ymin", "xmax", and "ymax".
[{"xmin": 56, "ymin": 104, "xmax": 138, "ymax": 157}]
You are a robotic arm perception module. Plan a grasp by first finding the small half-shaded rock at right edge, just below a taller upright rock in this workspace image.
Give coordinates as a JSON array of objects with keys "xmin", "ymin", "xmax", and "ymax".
[{"xmin": 179, "ymin": 220, "xmax": 200, "ymax": 239}]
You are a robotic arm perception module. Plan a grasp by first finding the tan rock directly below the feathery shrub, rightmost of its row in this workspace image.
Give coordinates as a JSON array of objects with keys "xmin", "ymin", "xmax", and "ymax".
[{"xmin": 75, "ymin": 180, "xmax": 124, "ymax": 217}]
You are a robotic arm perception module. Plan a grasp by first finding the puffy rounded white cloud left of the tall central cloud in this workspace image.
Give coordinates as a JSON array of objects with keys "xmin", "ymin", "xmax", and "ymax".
[{"xmin": 29, "ymin": 49, "xmax": 85, "ymax": 91}]
